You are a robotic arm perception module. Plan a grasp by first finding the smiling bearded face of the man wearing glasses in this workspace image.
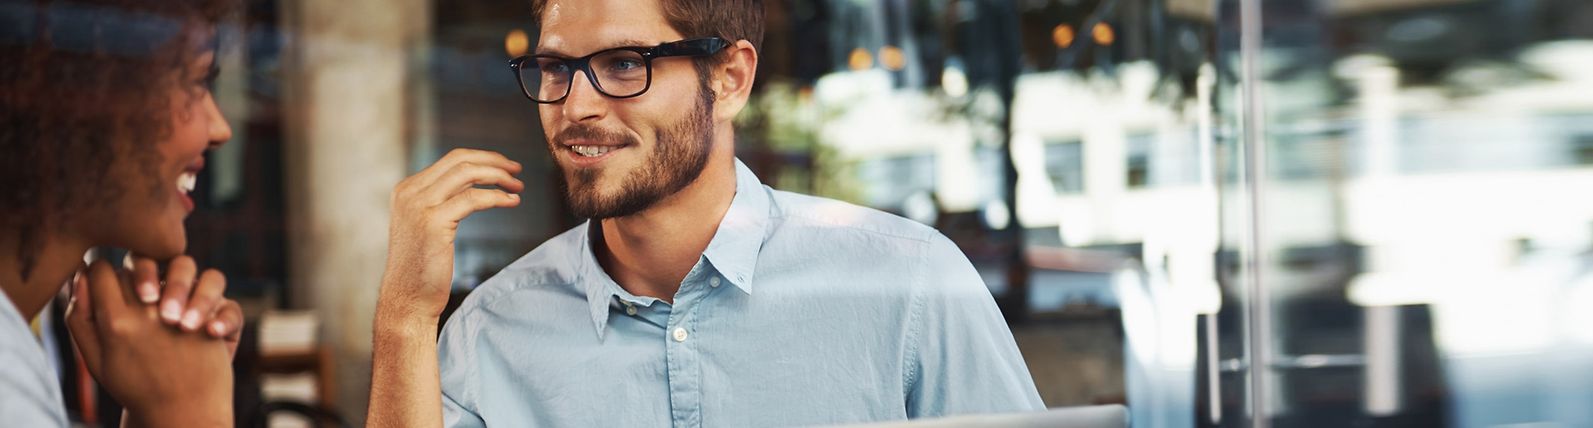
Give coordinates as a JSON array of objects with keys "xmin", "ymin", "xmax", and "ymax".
[{"xmin": 537, "ymin": 0, "xmax": 714, "ymax": 218}]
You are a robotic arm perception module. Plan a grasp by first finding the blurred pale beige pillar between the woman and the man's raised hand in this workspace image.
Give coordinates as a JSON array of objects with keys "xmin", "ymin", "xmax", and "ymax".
[{"xmin": 279, "ymin": 0, "xmax": 430, "ymax": 426}]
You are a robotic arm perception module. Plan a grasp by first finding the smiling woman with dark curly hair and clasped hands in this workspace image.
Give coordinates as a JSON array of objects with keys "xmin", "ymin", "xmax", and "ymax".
[{"xmin": 0, "ymin": 0, "xmax": 242, "ymax": 426}]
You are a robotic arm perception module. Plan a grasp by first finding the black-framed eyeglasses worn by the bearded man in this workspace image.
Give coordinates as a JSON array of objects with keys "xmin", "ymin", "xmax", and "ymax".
[{"xmin": 508, "ymin": 37, "xmax": 730, "ymax": 103}]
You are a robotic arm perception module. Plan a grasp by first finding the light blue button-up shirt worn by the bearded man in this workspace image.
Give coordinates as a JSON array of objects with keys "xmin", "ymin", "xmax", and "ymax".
[{"xmin": 438, "ymin": 161, "xmax": 1043, "ymax": 426}]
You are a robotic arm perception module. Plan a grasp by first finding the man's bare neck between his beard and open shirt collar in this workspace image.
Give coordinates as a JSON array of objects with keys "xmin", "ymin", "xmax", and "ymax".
[{"xmin": 593, "ymin": 153, "xmax": 736, "ymax": 304}]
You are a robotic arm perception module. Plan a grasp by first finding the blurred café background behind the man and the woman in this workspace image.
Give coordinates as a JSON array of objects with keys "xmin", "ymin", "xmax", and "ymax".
[{"xmin": 12, "ymin": 0, "xmax": 1593, "ymax": 426}]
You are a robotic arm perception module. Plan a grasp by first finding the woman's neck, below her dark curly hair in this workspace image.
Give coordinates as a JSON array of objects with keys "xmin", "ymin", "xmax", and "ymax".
[{"xmin": 0, "ymin": 232, "xmax": 89, "ymax": 320}]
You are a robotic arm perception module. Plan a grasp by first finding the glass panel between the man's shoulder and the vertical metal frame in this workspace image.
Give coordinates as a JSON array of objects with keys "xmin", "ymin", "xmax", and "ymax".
[{"xmin": 751, "ymin": 0, "xmax": 1244, "ymax": 416}]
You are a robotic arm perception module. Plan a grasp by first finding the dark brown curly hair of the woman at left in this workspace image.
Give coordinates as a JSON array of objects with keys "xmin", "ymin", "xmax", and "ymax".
[{"xmin": 0, "ymin": 0, "xmax": 236, "ymax": 278}]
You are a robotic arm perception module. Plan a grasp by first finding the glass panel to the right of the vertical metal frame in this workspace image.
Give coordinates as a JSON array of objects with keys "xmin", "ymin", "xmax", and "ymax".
[{"xmin": 1255, "ymin": 0, "xmax": 1593, "ymax": 426}]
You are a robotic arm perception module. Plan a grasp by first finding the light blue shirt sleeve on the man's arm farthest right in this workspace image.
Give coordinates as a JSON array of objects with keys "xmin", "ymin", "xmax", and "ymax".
[{"xmin": 905, "ymin": 232, "xmax": 1045, "ymax": 418}]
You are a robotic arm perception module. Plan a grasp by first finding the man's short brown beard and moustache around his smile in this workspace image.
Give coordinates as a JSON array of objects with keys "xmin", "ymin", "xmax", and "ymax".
[{"xmin": 550, "ymin": 84, "xmax": 714, "ymax": 220}]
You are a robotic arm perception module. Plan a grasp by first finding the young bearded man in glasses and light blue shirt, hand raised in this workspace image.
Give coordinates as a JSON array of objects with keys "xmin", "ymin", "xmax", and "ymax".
[{"xmin": 370, "ymin": 0, "xmax": 1043, "ymax": 426}]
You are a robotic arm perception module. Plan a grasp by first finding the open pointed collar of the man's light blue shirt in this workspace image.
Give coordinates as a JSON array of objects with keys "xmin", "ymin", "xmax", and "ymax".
[{"xmin": 570, "ymin": 159, "xmax": 769, "ymax": 340}]
